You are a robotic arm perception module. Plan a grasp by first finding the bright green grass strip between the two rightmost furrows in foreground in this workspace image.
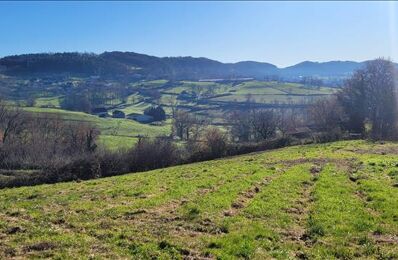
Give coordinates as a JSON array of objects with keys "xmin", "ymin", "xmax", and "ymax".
[{"xmin": 304, "ymin": 164, "xmax": 374, "ymax": 259}]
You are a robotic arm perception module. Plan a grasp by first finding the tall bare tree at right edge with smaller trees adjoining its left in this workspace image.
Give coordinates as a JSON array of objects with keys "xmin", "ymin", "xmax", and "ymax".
[{"xmin": 310, "ymin": 59, "xmax": 398, "ymax": 140}]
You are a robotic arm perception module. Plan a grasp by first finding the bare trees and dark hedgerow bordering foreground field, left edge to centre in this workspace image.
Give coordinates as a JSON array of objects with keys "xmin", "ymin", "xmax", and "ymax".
[{"xmin": 0, "ymin": 99, "xmax": 224, "ymax": 188}]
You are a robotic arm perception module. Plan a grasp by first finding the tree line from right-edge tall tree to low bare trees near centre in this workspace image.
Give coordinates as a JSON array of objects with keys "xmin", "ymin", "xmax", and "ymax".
[{"xmin": 230, "ymin": 59, "xmax": 398, "ymax": 142}]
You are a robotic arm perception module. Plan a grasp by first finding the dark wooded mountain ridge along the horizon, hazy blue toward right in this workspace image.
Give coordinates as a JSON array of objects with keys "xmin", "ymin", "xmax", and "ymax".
[{"xmin": 0, "ymin": 51, "xmax": 386, "ymax": 80}]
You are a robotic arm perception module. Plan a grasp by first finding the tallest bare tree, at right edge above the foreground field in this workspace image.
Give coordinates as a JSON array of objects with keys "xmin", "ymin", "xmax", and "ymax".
[{"xmin": 338, "ymin": 59, "xmax": 398, "ymax": 139}]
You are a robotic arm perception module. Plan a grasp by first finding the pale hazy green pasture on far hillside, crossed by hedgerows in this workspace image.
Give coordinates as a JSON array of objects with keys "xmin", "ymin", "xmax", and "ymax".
[{"xmin": 116, "ymin": 80, "xmax": 336, "ymax": 115}]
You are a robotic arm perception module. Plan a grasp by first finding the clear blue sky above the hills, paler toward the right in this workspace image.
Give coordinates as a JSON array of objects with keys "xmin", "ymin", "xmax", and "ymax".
[{"xmin": 0, "ymin": 2, "xmax": 398, "ymax": 67}]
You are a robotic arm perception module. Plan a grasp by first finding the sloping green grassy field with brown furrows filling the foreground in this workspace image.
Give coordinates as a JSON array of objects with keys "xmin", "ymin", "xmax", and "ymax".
[{"xmin": 0, "ymin": 141, "xmax": 398, "ymax": 259}]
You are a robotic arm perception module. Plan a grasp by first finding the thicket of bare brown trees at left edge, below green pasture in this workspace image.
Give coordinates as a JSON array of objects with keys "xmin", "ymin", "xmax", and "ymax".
[{"xmin": 0, "ymin": 103, "xmax": 98, "ymax": 169}]
